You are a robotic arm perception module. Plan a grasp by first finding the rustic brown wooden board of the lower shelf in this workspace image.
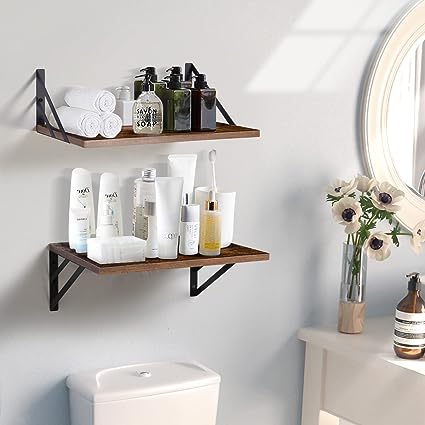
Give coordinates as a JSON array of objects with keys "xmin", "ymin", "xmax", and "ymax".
[{"xmin": 49, "ymin": 242, "xmax": 270, "ymax": 275}]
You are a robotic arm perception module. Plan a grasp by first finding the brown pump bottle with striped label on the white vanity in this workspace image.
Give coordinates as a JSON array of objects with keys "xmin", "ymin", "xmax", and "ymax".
[{"xmin": 394, "ymin": 273, "xmax": 425, "ymax": 360}]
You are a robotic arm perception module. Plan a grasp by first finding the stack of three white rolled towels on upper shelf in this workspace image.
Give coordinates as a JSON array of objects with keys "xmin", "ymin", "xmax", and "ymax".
[{"xmin": 49, "ymin": 87, "xmax": 122, "ymax": 139}]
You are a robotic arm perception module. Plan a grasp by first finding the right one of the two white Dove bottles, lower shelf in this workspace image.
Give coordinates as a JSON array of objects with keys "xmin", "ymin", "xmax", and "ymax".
[{"xmin": 97, "ymin": 173, "xmax": 123, "ymax": 236}]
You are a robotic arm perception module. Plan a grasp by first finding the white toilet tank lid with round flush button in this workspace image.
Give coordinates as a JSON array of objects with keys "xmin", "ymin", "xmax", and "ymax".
[{"xmin": 66, "ymin": 362, "xmax": 220, "ymax": 403}]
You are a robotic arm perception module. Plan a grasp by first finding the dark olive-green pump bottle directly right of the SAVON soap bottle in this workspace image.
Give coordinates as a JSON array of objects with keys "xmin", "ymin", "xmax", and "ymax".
[{"xmin": 159, "ymin": 74, "xmax": 191, "ymax": 132}]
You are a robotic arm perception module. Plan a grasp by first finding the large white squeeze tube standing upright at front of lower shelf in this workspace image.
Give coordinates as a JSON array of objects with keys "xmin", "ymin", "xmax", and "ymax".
[{"xmin": 155, "ymin": 177, "xmax": 183, "ymax": 260}]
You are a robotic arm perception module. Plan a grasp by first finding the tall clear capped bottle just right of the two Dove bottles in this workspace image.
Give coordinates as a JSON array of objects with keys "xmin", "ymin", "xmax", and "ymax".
[{"xmin": 133, "ymin": 168, "xmax": 156, "ymax": 240}]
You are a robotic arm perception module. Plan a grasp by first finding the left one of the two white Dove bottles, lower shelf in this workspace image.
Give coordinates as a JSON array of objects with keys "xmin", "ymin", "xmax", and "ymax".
[{"xmin": 68, "ymin": 168, "xmax": 96, "ymax": 249}]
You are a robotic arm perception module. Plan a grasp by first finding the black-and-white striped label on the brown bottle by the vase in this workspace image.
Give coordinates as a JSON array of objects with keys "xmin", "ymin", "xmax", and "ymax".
[{"xmin": 394, "ymin": 310, "xmax": 425, "ymax": 348}]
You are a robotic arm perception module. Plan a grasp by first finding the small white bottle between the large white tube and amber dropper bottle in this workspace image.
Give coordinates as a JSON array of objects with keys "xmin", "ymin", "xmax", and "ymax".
[{"xmin": 179, "ymin": 193, "xmax": 200, "ymax": 255}]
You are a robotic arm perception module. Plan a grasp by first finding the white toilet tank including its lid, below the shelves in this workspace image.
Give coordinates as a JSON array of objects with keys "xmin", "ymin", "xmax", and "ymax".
[{"xmin": 66, "ymin": 362, "xmax": 220, "ymax": 425}]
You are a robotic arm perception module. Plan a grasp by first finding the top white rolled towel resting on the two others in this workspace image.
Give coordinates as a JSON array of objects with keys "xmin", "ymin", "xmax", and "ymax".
[{"xmin": 65, "ymin": 87, "xmax": 116, "ymax": 114}]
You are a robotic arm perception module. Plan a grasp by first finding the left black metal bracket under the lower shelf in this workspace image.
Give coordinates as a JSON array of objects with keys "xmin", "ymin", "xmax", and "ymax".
[{"xmin": 49, "ymin": 251, "xmax": 85, "ymax": 311}]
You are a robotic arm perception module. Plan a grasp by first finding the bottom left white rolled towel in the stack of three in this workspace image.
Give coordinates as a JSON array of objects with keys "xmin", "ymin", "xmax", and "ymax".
[{"xmin": 49, "ymin": 106, "xmax": 102, "ymax": 138}]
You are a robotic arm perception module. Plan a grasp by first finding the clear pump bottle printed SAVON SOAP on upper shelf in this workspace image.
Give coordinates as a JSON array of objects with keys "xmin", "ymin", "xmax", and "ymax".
[{"xmin": 133, "ymin": 74, "xmax": 163, "ymax": 134}]
